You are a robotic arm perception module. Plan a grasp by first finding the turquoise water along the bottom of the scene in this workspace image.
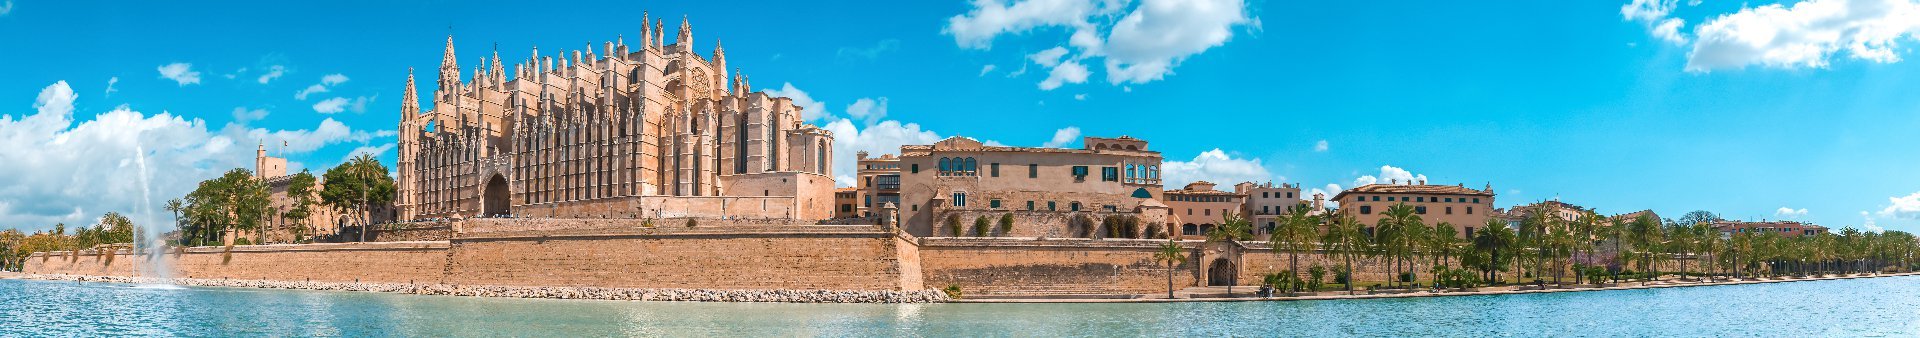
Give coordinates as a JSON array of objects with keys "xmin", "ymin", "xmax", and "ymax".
[{"xmin": 0, "ymin": 277, "xmax": 1920, "ymax": 336}]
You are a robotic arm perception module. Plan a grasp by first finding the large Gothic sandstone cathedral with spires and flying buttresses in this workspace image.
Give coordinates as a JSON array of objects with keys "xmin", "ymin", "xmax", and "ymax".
[{"xmin": 394, "ymin": 13, "xmax": 833, "ymax": 221}]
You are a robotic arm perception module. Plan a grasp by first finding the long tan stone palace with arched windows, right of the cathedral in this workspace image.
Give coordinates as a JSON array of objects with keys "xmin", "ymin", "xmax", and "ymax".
[{"xmin": 898, "ymin": 136, "xmax": 1165, "ymax": 236}]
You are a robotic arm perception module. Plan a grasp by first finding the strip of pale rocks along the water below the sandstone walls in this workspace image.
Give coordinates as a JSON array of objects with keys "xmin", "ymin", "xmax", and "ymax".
[{"xmin": 19, "ymin": 275, "xmax": 948, "ymax": 303}]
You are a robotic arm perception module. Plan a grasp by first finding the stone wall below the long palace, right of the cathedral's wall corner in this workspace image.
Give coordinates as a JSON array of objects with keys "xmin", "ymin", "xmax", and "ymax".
[{"xmin": 920, "ymin": 238, "xmax": 1200, "ymax": 296}]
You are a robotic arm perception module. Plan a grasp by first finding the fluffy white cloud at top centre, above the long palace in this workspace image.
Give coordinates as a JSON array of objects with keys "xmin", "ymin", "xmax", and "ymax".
[{"xmin": 945, "ymin": 0, "xmax": 1258, "ymax": 90}]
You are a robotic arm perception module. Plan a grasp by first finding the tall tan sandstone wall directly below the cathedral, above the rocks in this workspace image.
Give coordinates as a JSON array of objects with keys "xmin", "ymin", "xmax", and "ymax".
[{"xmin": 444, "ymin": 227, "xmax": 922, "ymax": 290}]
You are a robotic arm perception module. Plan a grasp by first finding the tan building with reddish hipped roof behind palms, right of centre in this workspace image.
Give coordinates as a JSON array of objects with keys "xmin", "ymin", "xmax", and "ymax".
[{"xmin": 1332, "ymin": 181, "xmax": 1494, "ymax": 236}]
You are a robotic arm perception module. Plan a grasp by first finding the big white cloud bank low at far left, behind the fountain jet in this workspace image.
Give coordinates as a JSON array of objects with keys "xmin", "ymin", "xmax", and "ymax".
[{"xmin": 0, "ymin": 81, "xmax": 392, "ymax": 229}]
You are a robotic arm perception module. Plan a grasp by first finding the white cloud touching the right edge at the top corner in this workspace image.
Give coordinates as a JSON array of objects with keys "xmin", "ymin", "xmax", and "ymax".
[{"xmin": 1686, "ymin": 0, "xmax": 1920, "ymax": 71}]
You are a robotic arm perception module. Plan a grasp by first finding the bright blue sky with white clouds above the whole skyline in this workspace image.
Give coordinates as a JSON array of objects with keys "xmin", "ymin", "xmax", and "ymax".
[{"xmin": 0, "ymin": 0, "xmax": 1920, "ymax": 230}]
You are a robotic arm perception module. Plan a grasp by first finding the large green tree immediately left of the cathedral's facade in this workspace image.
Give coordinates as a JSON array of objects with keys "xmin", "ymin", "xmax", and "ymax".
[{"xmin": 321, "ymin": 154, "xmax": 394, "ymax": 242}]
